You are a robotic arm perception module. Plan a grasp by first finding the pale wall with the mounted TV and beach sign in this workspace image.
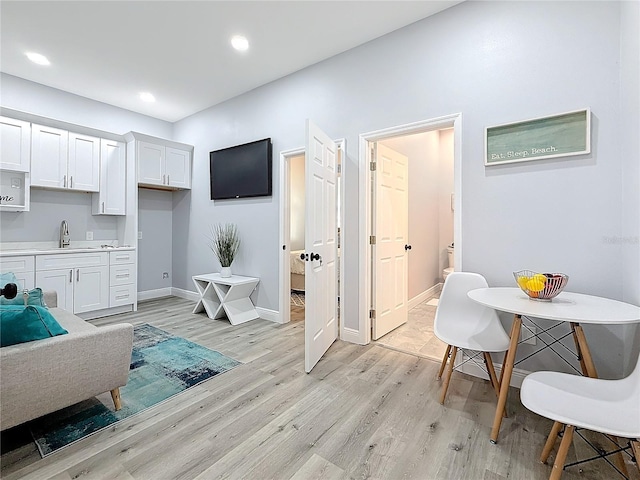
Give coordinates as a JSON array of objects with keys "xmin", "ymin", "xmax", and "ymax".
[{"xmin": 174, "ymin": 1, "xmax": 638, "ymax": 375}]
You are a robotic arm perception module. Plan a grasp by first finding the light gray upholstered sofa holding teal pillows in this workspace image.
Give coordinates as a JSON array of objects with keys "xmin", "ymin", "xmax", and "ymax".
[{"xmin": 0, "ymin": 292, "xmax": 133, "ymax": 430}]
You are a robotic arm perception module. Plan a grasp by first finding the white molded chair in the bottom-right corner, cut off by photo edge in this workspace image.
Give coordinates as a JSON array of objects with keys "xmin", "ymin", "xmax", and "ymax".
[{"xmin": 520, "ymin": 356, "xmax": 640, "ymax": 480}]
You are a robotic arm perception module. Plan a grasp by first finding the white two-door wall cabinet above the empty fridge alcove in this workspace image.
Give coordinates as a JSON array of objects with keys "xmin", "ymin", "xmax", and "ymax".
[{"xmin": 137, "ymin": 141, "xmax": 191, "ymax": 189}]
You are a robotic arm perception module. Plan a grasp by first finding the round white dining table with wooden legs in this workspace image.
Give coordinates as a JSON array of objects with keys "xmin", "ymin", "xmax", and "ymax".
[{"xmin": 467, "ymin": 287, "xmax": 640, "ymax": 443}]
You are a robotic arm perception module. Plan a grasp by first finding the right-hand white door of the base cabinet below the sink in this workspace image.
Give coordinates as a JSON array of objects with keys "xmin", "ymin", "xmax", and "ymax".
[{"xmin": 73, "ymin": 266, "xmax": 109, "ymax": 313}]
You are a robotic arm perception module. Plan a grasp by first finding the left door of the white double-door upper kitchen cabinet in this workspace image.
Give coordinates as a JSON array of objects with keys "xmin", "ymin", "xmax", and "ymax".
[{"xmin": 31, "ymin": 124, "xmax": 69, "ymax": 188}]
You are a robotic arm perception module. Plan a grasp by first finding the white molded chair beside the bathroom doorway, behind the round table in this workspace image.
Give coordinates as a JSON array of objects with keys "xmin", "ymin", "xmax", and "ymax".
[{"xmin": 433, "ymin": 272, "xmax": 509, "ymax": 403}]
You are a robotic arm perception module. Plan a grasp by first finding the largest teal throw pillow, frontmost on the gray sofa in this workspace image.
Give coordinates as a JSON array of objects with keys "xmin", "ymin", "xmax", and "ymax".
[{"xmin": 0, "ymin": 305, "xmax": 69, "ymax": 347}]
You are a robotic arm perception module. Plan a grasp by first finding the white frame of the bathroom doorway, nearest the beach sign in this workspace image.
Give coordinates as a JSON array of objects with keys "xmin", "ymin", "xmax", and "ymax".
[{"xmin": 360, "ymin": 113, "xmax": 463, "ymax": 345}]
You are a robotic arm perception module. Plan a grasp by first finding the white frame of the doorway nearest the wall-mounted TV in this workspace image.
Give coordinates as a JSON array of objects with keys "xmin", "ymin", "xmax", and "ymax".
[{"xmin": 278, "ymin": 138, "xmax": 346, "ymax": 330}]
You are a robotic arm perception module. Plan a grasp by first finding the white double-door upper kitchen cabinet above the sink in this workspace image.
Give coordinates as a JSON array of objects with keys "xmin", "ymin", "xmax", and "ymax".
[{"xmin": 31, "ymin": 124, "xmax": 100, "ymax": 192}]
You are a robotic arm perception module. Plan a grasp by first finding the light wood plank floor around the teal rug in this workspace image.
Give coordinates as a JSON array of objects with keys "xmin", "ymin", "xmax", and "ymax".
[{"xmin": 0, "ymin": 298, "xmax": 632, "ymax": 480}]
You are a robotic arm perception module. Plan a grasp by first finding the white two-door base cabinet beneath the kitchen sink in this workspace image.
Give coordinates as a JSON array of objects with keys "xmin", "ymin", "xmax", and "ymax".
[{"xmin": 36, "ymin": 252, "xmax": 109, "ymax": 313}]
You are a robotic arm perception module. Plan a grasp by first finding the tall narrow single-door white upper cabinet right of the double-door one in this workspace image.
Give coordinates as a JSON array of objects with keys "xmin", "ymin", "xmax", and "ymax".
[{"xmin": 92, "ymin": 138, "xmax": 127, "ymax": 215}]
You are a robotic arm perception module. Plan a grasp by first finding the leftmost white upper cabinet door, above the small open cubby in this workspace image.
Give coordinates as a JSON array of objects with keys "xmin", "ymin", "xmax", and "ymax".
[{"xmin": 0, "ymin": 117, "xmax": 31, "ymax": 172}]
